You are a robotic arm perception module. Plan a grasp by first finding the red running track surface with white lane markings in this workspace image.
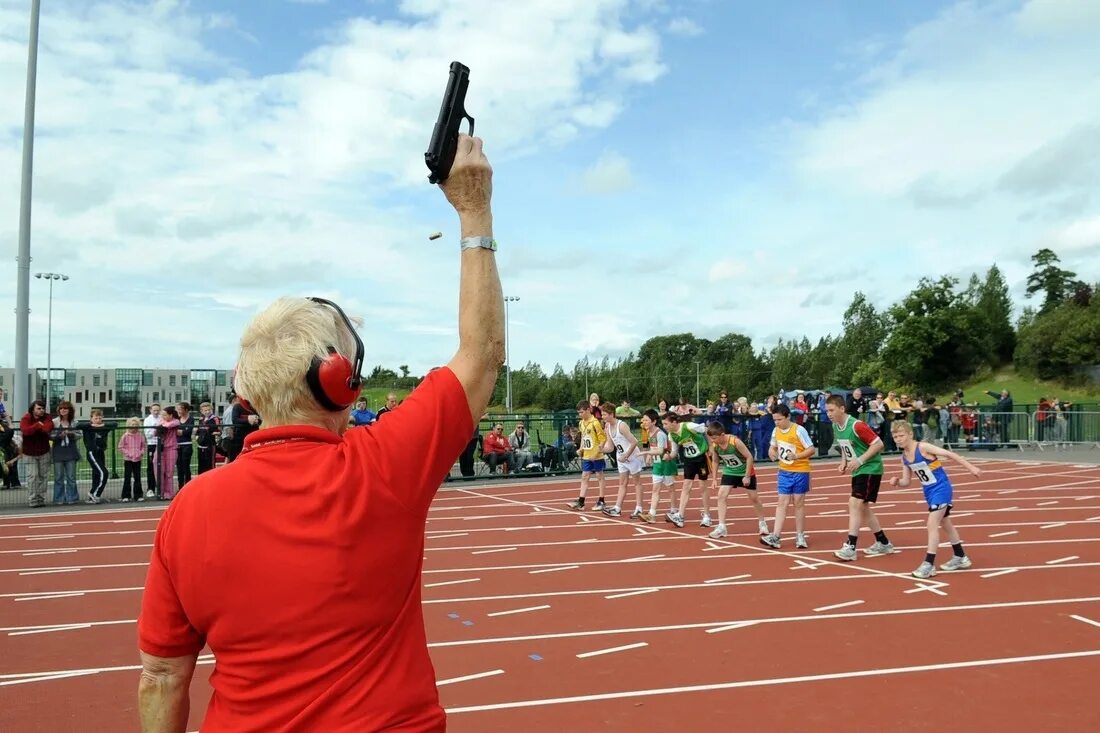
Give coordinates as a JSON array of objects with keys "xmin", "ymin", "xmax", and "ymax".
[{"xmin": 0, "ymin": 459, "xmax": 1100, "ymax": 733}]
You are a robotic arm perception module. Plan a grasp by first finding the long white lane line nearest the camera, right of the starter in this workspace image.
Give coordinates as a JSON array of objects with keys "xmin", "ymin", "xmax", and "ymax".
[{"xmin": 446, "ymin": 649, "xmax": 1100, "ymax": 715}]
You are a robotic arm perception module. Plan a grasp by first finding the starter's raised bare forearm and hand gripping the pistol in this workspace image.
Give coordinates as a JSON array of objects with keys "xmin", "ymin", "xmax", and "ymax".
[{"xmin": 440, "ymin": 134, "xmax": 504, "ymax": 424}]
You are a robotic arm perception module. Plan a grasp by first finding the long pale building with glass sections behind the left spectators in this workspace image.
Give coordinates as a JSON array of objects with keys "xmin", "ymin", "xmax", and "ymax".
[{"xmin": 0, "ymin": 368, "xmax": 233, "ymax": 419}]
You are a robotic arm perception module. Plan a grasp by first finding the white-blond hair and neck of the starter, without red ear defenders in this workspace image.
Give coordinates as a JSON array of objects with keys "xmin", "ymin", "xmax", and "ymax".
[{"xmin": 233, "ymin": 297, "xmax": 360, "ymax": 433}]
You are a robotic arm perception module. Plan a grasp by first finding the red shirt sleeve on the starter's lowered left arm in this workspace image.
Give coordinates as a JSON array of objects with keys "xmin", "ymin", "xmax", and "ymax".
[{"xmin": 138, "ymin": 510, "xmax": 206, "ymax": 658}]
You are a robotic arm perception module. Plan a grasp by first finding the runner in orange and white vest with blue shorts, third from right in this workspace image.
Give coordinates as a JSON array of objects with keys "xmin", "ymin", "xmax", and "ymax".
[{"xmin": 760, "ymin": 404, "xmax": 817, "ymax": 549}]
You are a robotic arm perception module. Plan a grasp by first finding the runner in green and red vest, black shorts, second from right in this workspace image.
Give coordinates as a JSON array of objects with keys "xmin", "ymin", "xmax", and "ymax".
[{"xmin": 825, "ymin": 394, "xmax": 894, "ymax": 562}]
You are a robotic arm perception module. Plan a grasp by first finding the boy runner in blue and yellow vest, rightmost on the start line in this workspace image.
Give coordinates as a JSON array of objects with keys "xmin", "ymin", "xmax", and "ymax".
[{"xmin": 890, "ymin": 420, "xmax": 981, "ymax": 578}]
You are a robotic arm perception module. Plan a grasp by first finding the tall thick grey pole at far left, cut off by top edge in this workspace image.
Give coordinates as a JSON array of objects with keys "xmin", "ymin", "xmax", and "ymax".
[{"xmin": 11, "ymin": 0, "xmax": 40, "ymax": 416}]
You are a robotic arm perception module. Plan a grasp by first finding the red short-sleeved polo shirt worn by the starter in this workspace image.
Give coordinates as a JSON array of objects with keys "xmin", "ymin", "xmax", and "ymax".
[{"xmin": 138, "ymin": 369, "xmax": 473, "ymax": 733}]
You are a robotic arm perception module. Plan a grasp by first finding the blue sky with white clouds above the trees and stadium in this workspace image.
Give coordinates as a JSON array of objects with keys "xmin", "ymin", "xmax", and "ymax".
[{"xmin": 0, "ymin": 0, "xmax": 1100, "ymax": 373}]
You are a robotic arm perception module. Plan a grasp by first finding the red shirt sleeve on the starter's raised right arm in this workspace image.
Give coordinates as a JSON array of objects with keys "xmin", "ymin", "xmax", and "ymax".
[{"xmin": 344, "ymin": 367, "xmax": 473, "ymax": 515}]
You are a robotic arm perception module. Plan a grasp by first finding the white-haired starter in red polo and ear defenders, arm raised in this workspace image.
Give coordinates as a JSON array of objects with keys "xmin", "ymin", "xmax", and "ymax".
[{"xmin": 138, "ymin": 135, "xmax": 504, "ymax": 733}]
